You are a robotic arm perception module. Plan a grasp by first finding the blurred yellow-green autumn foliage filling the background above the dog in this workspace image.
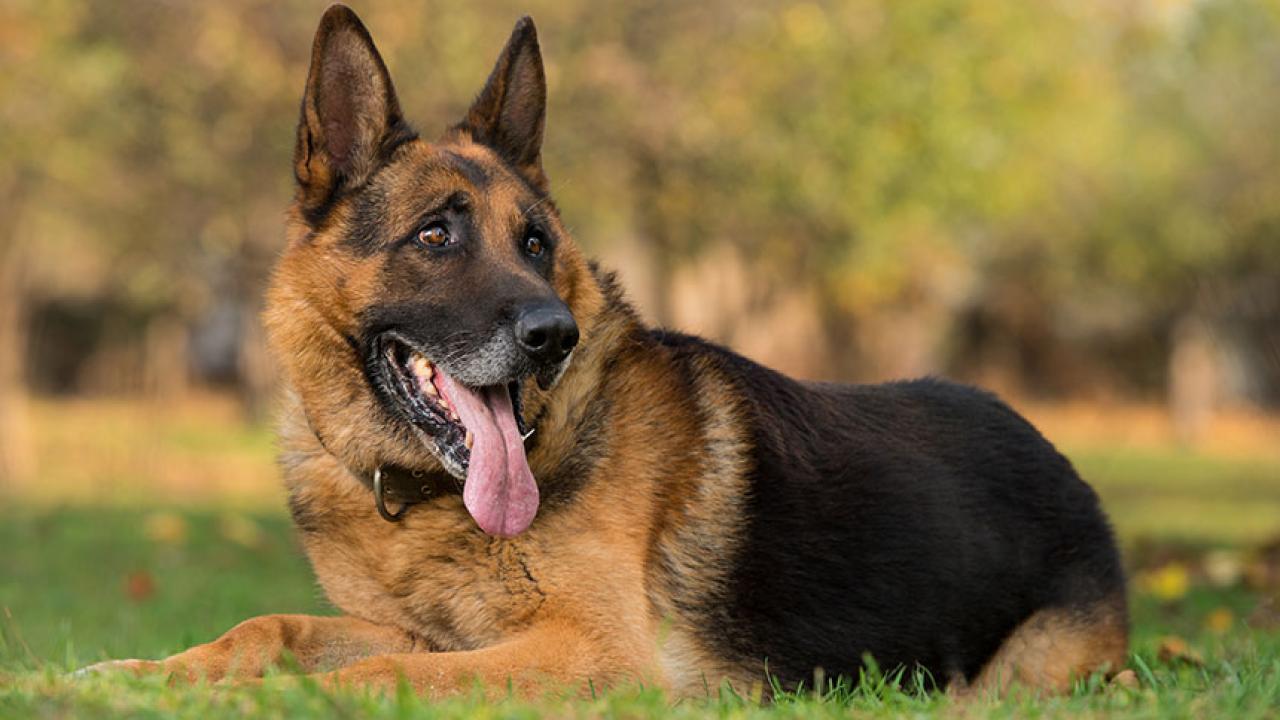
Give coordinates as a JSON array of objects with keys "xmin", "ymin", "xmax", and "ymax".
[{"xmin": 0, "ymin": 0, "xmax": 1280, "ymax": 398}]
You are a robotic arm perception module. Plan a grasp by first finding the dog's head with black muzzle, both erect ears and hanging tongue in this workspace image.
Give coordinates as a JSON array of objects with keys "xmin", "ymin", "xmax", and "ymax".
[{"xmin": 266, "ymin": 5, "xmax": 599, "ymax": 536}]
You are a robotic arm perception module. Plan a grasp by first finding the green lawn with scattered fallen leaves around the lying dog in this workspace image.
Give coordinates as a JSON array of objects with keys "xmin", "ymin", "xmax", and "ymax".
[{"xmin": 0, "ymin": 394, "xmax": 1280, "ymax": 719}]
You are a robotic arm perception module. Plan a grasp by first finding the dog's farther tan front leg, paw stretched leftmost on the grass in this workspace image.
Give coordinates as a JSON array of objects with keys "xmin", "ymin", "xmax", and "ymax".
[{"xmin": 81, "ymin": 615, "xmax": 422, "ymax": 682}]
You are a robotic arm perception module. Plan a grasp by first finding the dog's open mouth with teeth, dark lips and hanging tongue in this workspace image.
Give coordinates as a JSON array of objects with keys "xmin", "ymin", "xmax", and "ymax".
[{"xmin": 375, "ymin": 336, "xmax": 539, "ymax": 537}]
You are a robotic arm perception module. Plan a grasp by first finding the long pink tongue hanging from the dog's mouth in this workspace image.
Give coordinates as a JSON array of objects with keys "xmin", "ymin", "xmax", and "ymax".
[{"xmin": 435, "ymin": 373, "xmax": 538, "ymax": 538}]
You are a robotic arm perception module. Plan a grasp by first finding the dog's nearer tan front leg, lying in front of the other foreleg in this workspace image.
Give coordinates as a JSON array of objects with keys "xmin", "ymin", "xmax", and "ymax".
[{"xmin": 315, "ymin": 624, "xmax": 629, "ymax": 697}]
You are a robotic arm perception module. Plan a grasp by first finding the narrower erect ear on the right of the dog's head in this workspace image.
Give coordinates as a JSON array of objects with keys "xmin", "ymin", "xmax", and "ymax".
[{"xmin": 458, "ymin": 17, "xmax": 547, "ymax": 190}]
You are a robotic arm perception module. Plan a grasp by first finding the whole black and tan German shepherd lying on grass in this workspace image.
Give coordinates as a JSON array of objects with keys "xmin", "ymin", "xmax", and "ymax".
[{"xmin": 85, "ymin": 5, "xmax": 1128, "ymax": 696}]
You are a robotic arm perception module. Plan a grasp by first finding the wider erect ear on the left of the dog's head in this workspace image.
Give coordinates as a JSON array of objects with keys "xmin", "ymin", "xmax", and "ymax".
[{"xmin": 293, "ymin": 5, "xmax": 413, "ymax": 211}]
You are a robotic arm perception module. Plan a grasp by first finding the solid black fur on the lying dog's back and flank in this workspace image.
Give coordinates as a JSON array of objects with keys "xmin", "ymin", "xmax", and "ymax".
[{"xmin": 660, "ymin": 333, "xmax": 1126, "ymax": 683}]
